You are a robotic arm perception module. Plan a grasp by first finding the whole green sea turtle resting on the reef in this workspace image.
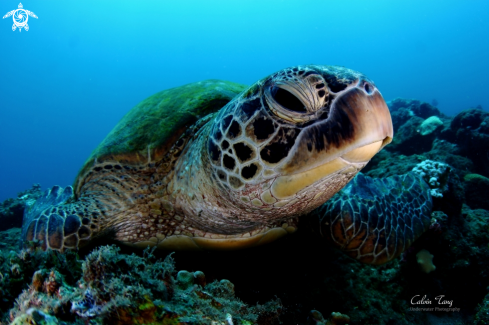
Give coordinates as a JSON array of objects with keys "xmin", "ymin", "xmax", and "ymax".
[{"xmin": 22, "ymin": 65, "xmax": 431, "ymax": 264}]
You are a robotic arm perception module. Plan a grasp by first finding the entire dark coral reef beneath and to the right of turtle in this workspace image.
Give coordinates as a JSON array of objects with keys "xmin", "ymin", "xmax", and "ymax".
[{"xmin": 0, "ymin": 99, "xmax": 489, "ymax": 325}]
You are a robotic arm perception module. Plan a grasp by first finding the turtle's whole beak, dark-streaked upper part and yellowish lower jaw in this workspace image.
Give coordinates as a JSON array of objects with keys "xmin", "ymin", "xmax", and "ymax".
[{"xmin": 272, "ymin": 81, "xmax": 394, "ymax": 198}]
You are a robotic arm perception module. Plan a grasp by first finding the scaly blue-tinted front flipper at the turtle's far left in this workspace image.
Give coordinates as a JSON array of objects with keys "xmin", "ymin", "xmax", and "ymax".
[{"xmin": 22, "ymin": 186, "xmax": 86, "ymax": 251}]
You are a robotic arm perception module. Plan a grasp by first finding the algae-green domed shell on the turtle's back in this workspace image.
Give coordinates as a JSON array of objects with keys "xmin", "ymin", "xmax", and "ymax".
[{"xmin": 75, "ymin": 80, "xmax": 247, "ymax": 188}]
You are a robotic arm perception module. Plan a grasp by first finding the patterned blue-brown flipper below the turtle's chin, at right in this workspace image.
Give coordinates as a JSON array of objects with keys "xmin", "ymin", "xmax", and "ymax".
[{"xmin": 313, "ymin": 173, "xmax": 432, "ymax": 265}]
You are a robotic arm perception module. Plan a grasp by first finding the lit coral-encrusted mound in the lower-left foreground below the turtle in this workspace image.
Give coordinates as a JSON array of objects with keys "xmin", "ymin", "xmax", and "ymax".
[{"xmin": 3, "ymin": 246, "xmax": 282, "ymax": 325}]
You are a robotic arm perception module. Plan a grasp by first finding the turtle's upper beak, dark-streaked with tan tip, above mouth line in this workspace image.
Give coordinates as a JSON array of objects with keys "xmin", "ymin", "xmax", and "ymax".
[{"xmin": 278, "ymin": 81, "xmax": 394, "ymax": 175}]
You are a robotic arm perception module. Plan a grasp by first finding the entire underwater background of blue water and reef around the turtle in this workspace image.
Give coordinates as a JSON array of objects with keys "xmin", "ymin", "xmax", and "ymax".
[{"xmin": 0, "ymin": 0, "xmax": 489, "ymax": 325}]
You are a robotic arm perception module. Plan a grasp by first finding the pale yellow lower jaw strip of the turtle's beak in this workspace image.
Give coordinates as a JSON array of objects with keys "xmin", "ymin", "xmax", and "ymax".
[{"xmin": 271, "ymin": 137, "xmax": 392, "ymax": 199}]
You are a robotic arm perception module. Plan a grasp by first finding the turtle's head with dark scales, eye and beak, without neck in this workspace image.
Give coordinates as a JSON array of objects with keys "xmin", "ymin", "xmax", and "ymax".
[{"xmin": 207, "ymin": 65, "xmax": 393, "ymax": 214}]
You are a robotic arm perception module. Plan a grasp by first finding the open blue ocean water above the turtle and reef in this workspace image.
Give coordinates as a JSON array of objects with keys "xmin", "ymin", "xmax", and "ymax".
[{"xmin": 0, "ymin": 0, "xmax": 489, "ymax": 201}]
